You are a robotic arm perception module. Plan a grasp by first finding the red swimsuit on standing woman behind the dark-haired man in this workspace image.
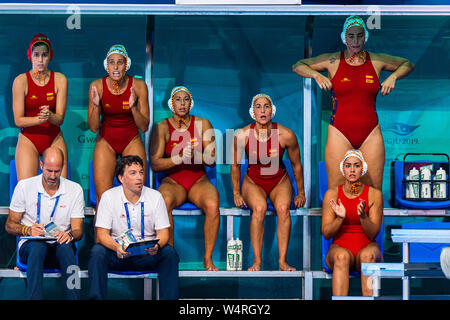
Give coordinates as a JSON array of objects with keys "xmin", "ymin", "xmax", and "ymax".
[{"xmin": 99, "ymin": 77, "xmax": 139, "ymax": 154}]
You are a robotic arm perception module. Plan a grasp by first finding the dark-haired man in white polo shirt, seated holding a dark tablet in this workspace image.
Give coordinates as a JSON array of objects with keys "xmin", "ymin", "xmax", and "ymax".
[{"xmin": 88, "ymin": 156, "xmax": 180, "ymax": 300}]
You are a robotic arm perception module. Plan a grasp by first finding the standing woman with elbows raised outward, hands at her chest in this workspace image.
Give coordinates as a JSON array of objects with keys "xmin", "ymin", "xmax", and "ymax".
[{"xmin": 293, "ymin": 16, "xmax": 414, "ymax": 190}]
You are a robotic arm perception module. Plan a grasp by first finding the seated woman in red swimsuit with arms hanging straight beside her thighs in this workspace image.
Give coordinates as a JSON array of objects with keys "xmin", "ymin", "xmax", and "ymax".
[{"xmin": 231, "ymin": 94, "xmax": 305, "ymax": 271}]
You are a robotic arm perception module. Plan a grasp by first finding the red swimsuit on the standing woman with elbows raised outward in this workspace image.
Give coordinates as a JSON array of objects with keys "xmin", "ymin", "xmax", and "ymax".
[{"xmin": 330, "ymin": 52, "xmax": 380, "ymax": 149}]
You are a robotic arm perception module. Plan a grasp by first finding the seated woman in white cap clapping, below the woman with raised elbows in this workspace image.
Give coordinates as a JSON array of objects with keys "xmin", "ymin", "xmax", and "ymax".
[{"xmin": 322, "ymin": 150, "xmax": 383, "ymax": 296}]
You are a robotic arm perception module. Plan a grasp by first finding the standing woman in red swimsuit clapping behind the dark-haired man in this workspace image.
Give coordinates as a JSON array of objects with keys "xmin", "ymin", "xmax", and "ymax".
[{"xmin": 88, "ymin": 44, "xmax": 150, "ymax": 205}]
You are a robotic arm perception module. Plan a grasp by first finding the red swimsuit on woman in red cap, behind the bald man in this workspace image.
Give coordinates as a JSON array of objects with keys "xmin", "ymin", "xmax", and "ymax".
[{"xmin": 20, "ymin": 72, "xmax": 61, "ymax": 155}]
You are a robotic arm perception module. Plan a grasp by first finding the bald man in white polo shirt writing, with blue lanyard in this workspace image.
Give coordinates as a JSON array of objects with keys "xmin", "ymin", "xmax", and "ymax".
[{"xmin": 5, "ymin": 147, "xmax": 84, "ymax": 300}]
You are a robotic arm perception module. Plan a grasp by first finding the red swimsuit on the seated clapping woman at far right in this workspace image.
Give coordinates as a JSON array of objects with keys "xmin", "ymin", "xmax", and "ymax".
[{"xmin": 333, "ymin": 185, "xmax": 371, "ymax": 258}]
